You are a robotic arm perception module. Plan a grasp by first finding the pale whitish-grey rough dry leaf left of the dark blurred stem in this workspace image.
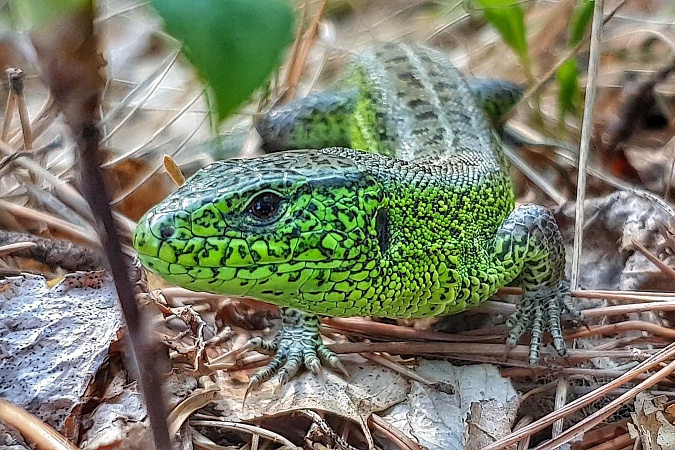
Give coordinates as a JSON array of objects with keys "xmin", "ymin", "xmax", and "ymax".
[{"xmin": 0, "ymin": 272, "xmax": 122, "ymax": 437}]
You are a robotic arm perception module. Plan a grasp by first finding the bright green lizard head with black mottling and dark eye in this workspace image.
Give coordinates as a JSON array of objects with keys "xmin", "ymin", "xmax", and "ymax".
[{"xmin": 134, "ymin": 149, "xmax": 388, "ymax": 314}]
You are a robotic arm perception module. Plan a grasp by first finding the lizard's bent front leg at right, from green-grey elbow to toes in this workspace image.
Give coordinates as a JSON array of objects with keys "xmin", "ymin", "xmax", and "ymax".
[{"xmin": 494, "ymin": 205, "xmax": 579, "ymax": 365}]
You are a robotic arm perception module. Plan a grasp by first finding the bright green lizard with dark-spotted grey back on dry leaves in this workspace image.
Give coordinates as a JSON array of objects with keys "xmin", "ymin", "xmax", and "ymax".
[{"xmin": 134, "ymin": 44, "xmax": 580, "ymax": 386}]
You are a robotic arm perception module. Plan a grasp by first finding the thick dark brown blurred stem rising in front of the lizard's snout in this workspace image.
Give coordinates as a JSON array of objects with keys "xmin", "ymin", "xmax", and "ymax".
[{"xmin": 31, "ymin": 5, "xmax": 172, "ymax": 450}]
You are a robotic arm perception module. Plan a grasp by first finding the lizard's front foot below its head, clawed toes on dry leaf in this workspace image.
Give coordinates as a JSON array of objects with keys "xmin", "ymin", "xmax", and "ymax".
[{"xmin": 242, "ymin": 308, "xmax": 347, "ymax": 392}]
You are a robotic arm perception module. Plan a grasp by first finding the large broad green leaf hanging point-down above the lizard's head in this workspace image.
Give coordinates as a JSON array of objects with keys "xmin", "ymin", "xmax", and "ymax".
[{"xmin": 151, "ymin": 0, "xmax": 295, "ymax": 120}]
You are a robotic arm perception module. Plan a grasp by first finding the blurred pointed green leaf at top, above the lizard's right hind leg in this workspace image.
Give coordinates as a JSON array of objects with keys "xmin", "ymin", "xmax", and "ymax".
[{"xmin": 475, "ymin": 0, "xmax": 528, "ymax": 62}]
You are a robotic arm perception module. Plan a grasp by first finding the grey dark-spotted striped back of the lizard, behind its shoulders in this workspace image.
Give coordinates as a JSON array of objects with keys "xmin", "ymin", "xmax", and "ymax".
[{"xmin": 348, "ymin": 43, "xmax": 507, "ymax": 171}]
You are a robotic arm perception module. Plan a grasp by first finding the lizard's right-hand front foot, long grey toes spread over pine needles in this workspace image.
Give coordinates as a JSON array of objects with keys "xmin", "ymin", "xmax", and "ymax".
[{"xmin": 506, "ymin": 281, "xmax": 580, "ymax": 366}]
